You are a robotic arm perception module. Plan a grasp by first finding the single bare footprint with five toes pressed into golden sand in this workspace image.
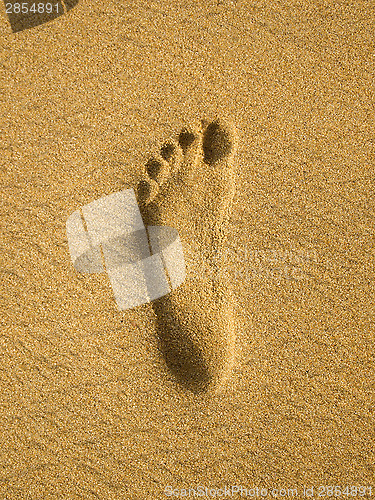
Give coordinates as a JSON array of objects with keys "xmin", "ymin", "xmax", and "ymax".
[{"xmin": 137, "ymin": 119, "xmax": 237, "ymax": 394}]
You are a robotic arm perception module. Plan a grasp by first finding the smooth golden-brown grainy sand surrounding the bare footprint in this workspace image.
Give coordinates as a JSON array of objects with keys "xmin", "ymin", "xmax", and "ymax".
[{"xmin": 0, "ymin": 0, "xmax": 375, "ymax": 500}]
